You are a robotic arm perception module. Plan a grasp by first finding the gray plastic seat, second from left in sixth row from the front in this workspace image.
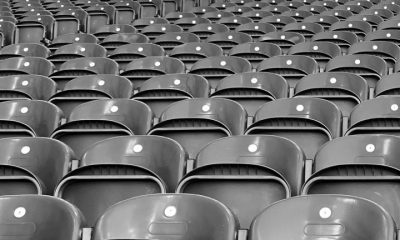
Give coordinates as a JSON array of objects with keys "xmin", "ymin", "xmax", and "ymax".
[{"xmin": 47, "ymin": 43, "xmax": 107, "ymax": 69}]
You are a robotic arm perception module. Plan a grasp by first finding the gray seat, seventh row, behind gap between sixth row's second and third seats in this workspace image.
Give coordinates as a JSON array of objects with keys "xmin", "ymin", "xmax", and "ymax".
[{"xmin": 100, "ymin": 33, "xmax": 150, "ymax": 53}]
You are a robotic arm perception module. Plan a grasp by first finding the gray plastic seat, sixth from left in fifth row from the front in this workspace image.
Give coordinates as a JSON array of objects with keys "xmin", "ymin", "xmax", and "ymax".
[{"xmin": 325, "ymin": 54, "xmax": 387, "ymax": 91}]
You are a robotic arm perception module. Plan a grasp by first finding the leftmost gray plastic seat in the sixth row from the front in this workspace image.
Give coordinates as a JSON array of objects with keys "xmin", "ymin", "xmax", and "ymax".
[{"xmin": 0, "ymin": 43, "xmax": 50, "ymax": 59}]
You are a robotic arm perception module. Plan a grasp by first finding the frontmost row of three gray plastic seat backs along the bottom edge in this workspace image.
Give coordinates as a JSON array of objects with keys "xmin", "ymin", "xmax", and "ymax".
[{"xmin": 0, "ymin": 194, "xmax": 396, "ymax": 240}]
